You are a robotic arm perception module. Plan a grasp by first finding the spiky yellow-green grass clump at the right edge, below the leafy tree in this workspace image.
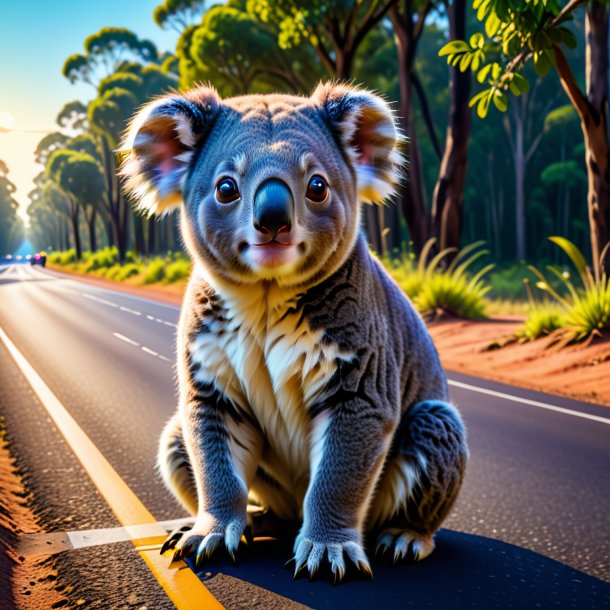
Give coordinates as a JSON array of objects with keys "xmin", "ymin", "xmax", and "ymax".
[{"xmin": 529, "ymin": 237, "xmax": 610, "ymax": 344}]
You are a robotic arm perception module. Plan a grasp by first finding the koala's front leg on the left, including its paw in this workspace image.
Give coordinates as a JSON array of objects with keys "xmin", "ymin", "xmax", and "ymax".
[{"xmin": 167, "ymin": 284, "xmax": 263, "ymax": 560}]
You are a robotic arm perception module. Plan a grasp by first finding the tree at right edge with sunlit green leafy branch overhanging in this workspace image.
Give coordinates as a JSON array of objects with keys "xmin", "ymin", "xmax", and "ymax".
[{"xmin": 443, "ymin": 0, "xmax": 610, "ymax": 278}]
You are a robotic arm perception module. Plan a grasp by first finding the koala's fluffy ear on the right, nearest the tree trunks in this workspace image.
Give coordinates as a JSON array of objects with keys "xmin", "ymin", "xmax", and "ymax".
[{"xmin": 312, "ymin": 83, "xmax": 405, "ymax": 203}]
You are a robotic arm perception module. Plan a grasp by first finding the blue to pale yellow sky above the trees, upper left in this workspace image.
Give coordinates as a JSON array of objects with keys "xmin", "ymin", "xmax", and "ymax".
[{"xmin": 0, "ymin": 0, "xmax": 177, "ymax": 223}]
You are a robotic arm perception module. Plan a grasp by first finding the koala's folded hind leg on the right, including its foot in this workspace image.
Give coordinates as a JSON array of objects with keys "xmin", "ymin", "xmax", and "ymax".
[{"xmin": 369, "ymin": 401, "xmax": 468, "ymax": 562}]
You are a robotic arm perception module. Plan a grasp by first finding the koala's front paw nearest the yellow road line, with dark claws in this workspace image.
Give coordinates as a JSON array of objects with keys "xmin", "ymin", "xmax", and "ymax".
[{"xmin": 161, "ymin": 513, "xmax": 246, "ymax": 567}]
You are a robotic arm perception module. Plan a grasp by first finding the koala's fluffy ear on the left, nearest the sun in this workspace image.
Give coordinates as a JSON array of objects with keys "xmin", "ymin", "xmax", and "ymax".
[{"xmin": 120, "ymin": 87, "xmax": 220, "ymax": 216}]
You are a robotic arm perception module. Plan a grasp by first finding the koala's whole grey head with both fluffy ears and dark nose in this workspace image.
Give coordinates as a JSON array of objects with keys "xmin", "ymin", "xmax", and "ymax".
[{"xmin": 122, "ymin": 84, "xmax": 401, "ymax": 285}]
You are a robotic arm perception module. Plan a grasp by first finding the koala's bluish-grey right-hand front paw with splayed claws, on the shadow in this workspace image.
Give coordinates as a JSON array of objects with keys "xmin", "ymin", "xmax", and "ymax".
[{"xmin": 294, "ymin": 529, "xmax": 373, "ymax": 583}]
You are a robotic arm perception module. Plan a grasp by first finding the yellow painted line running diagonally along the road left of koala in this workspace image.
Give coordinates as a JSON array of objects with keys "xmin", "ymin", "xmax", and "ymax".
[{"xmin": 0, "ymin": 327, "xmax": 222, "ymax": 610}]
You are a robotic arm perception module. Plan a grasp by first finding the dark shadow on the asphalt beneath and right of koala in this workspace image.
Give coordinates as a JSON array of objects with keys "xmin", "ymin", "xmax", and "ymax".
[{"xmin": 186, "ymin": 530, "xmax": 610, "ymax": 610}]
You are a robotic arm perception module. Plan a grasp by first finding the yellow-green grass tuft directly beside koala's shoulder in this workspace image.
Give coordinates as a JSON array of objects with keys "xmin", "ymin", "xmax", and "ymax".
[{"xmin": 382, "ymin": 239, "xmax": 493, "ymax": 319}]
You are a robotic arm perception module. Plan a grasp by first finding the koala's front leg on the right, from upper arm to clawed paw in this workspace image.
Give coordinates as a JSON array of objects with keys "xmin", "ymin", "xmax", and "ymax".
[{"xmin": 295, "ymin": 351, "xmax": 395, "ymax": 579}]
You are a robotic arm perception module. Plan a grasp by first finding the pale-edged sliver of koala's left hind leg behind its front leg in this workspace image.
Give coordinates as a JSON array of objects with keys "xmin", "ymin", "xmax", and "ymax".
[{"xmin": 157, "ymin": 413, "xmax": 197, "ymax": 515}]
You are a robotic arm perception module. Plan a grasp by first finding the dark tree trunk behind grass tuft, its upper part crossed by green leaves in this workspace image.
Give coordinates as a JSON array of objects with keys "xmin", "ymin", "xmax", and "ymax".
[{"xmin": 432, "ymin": 0, "xmax": 470, "ymax": 250}]
